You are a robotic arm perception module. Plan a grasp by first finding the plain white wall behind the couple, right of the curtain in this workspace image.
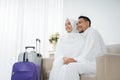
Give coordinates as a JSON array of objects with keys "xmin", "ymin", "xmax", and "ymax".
[{"xmin": 63, "ymin": 0, "xmax": 120, "ymax": 45}]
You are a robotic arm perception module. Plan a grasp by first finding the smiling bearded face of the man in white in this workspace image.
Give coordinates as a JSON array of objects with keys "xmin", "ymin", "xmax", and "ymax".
[{"xmin": 77, "ymin": 18, "xmax": 89, "ymax": 32}]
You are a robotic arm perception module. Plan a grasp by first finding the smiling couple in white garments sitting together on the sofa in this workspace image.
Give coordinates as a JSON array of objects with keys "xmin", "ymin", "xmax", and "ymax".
[{"xmin": 49, "ymin": 16, "xmax": 107, "ymax": 80}]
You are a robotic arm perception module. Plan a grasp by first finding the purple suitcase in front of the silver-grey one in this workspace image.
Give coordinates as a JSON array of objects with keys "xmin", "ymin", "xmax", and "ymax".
[{"xmin": 11, "ymin": 53, "xmax": 40, "ymax": 80}]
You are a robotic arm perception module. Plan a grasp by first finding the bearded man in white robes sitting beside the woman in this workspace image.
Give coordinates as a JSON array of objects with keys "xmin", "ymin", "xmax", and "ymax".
[{"xmin": 57, "ymin": 16, "xmax": 107, "ymax": 80}]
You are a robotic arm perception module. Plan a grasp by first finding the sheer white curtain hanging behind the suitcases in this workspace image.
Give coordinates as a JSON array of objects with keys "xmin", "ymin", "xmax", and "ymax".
[{"xmin": 0, "ymin": 0, "xmax": 63, "ymax": 80}]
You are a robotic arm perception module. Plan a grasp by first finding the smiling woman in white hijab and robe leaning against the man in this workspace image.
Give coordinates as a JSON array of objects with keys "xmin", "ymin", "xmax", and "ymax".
[{"xmin": 49, "ymin": 19, "xmax": 84, "ymax": 80}]
